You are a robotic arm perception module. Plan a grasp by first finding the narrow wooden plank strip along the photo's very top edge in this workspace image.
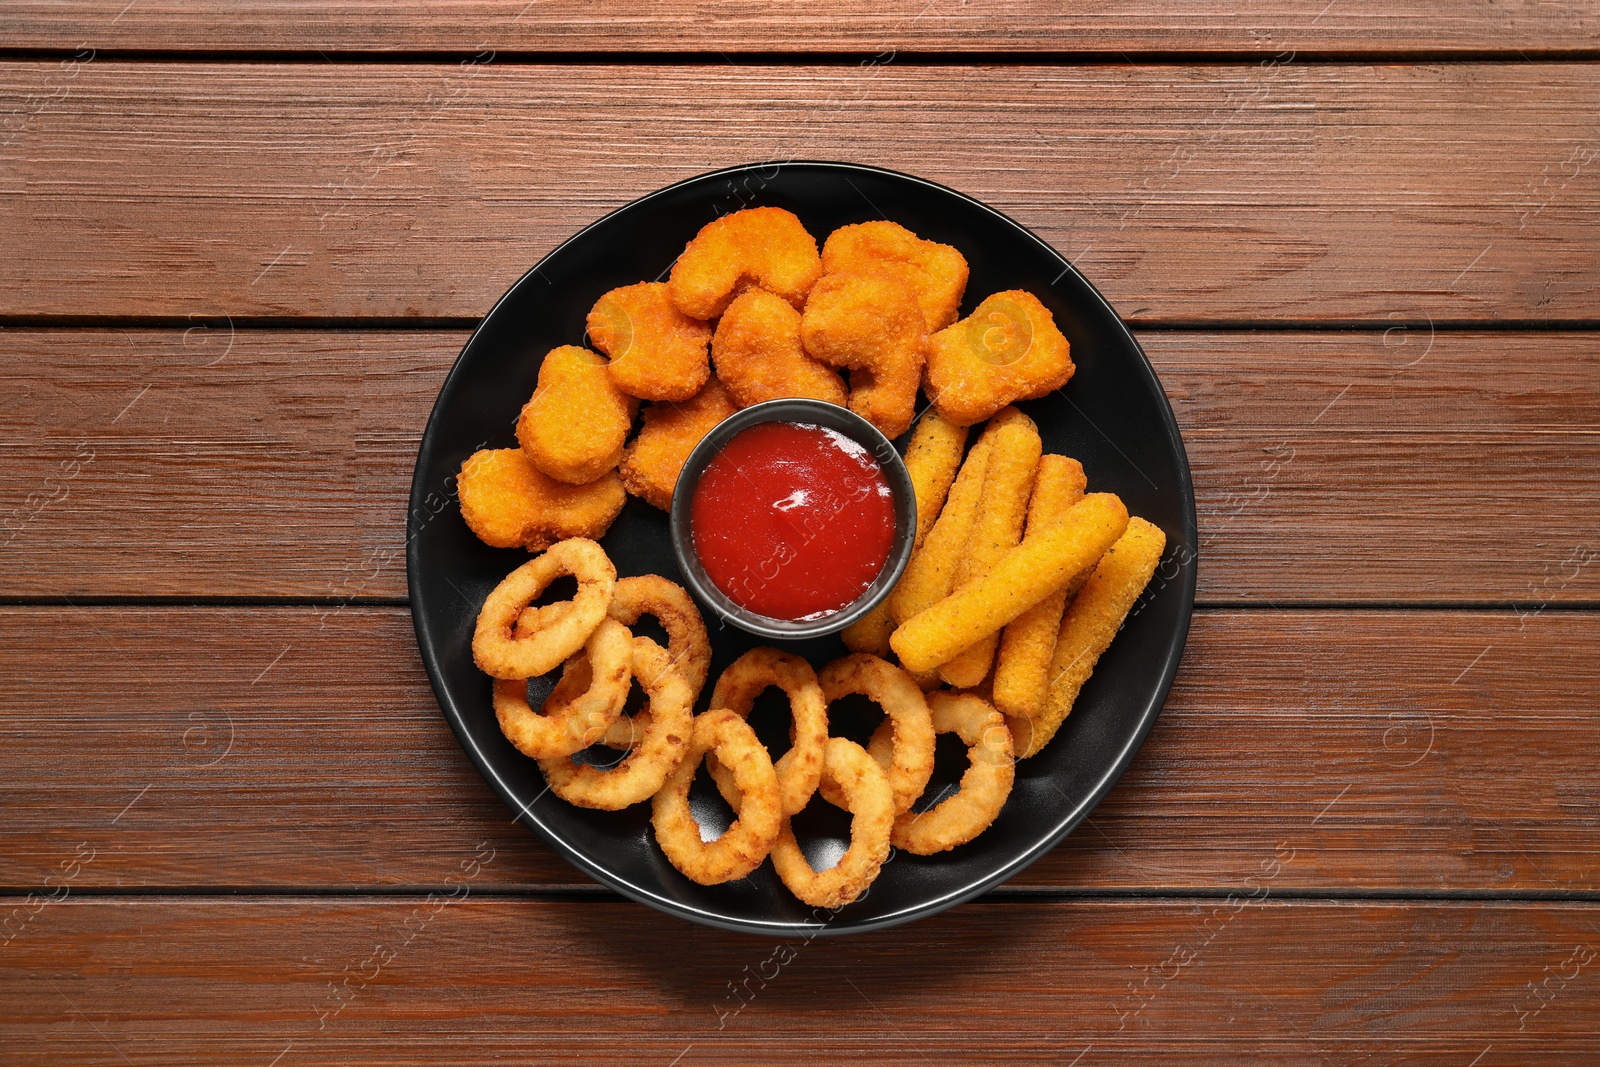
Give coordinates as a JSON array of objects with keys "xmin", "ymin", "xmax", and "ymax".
[{"xmin": 0, "ymin": 0, "xmax": 1600, "ymax": 56}]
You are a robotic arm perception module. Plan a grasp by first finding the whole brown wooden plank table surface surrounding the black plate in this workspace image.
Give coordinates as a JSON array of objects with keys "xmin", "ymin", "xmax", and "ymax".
[{"xmin": 0, "ymin": 0, "xmax": 1600, "ymax": 1067}]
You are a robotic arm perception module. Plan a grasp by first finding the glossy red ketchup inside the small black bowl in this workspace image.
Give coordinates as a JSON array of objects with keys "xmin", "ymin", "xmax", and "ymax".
[{"xmin": 690, "ymin": 422, "xmax": 894, "ymax": 619}]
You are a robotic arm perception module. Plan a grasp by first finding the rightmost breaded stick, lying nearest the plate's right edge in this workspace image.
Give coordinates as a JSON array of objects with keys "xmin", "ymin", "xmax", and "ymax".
[{"xmin": 1006, "ymin": 518, "xmax": 1166, "ymax": 758}]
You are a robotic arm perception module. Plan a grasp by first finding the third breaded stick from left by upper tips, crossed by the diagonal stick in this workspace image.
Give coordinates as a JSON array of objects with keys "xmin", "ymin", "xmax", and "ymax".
[{"xmin": 939, "ymin": 408, "xmax": 1043, "ymax": 689}]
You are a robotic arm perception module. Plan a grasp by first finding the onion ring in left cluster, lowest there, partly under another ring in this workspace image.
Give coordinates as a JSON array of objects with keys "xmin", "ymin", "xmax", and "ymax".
[{"xmin": 539, "ymin": 624, "xmax": 693, "ymax": 811}]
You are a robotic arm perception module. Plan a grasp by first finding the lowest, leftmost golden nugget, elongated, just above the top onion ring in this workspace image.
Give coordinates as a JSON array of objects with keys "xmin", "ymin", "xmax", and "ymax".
[{"xmin": 456, "ymin": 448, "xmax": 627, "ymax": 552}]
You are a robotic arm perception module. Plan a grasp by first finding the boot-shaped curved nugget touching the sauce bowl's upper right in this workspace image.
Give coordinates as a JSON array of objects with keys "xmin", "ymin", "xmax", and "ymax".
[{"xmin": 800, "ymin": 274, "xmax": 928, "ymax": 438}]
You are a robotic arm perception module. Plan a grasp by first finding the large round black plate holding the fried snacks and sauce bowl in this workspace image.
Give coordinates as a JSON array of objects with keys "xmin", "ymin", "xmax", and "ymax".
[{"xmin": 406, "ymin": 163, "xmax": 1197, "ymax": 934}]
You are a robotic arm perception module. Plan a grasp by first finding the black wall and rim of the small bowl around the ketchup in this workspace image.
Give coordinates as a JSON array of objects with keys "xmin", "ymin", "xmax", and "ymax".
[{"xmin": 670, "ymin": 397, "xmax": 917, "ymax": 641}]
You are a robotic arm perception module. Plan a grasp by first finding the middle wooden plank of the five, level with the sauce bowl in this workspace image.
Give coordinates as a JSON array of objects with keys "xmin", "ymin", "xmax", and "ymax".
[{"xmin": 0, "ymin": 323, "xmax": 1600, "ymax": 608}]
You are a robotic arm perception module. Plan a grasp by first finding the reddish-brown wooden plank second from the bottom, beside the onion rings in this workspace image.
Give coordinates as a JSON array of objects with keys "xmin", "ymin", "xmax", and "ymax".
[{"xmin": 0, "ymin": 608, "xmax": 1600, "ymax": 893}]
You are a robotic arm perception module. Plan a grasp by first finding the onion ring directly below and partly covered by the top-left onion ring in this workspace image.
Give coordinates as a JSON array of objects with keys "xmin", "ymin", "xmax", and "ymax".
[{"xmin": 494, "ymin": 619, "xmax": 634, "ymax": 760}]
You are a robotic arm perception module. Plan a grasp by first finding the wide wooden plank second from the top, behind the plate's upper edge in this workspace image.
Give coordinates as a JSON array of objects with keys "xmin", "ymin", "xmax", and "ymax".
[{"xmin": 0, "ymin": 61, "xmax": 1600, "ymax": 325}]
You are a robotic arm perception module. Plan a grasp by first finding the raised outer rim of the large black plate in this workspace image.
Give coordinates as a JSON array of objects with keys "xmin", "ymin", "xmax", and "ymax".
[{"xmin": 406, "ymin": 160, "xmax": 1200, "ymax": 936}]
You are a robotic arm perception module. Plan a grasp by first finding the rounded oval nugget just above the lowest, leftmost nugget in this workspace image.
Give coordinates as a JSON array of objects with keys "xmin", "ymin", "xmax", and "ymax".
[{"xmin": 517, "ymin": 344, "xmax": 638, "ymax": 485}]
